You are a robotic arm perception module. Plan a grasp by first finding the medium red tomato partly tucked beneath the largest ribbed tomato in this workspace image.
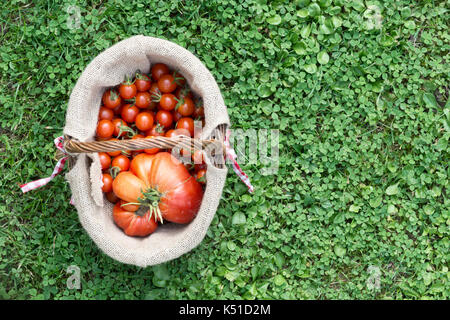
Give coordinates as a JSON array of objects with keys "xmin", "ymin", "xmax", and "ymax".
[{"xmin": 113, "ymin": 202, "xmax": 158, "ymax": 237}]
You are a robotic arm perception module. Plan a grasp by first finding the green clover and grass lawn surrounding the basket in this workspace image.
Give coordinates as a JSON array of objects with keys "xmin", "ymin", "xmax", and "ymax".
[{"xmin": 0, "ymin": 0, "xmax": 450, "ymax": 299}]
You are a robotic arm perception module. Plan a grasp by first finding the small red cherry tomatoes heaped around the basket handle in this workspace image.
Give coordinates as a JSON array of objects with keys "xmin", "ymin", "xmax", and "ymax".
[{"xmin": 96, "ymin": 63, "xmax": 206, "ymax": 203}]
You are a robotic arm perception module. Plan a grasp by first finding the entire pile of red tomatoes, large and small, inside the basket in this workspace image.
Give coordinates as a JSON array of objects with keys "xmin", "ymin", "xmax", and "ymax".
[{"xmin": 96, "ymin": 63, "xmax": 206, "ymax": 237}]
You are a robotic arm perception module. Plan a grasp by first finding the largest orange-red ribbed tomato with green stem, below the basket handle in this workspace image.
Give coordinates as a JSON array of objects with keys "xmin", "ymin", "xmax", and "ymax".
[{"xmin": 113, "ymin": 152, "xmax": 203, "ymax": 226}]
